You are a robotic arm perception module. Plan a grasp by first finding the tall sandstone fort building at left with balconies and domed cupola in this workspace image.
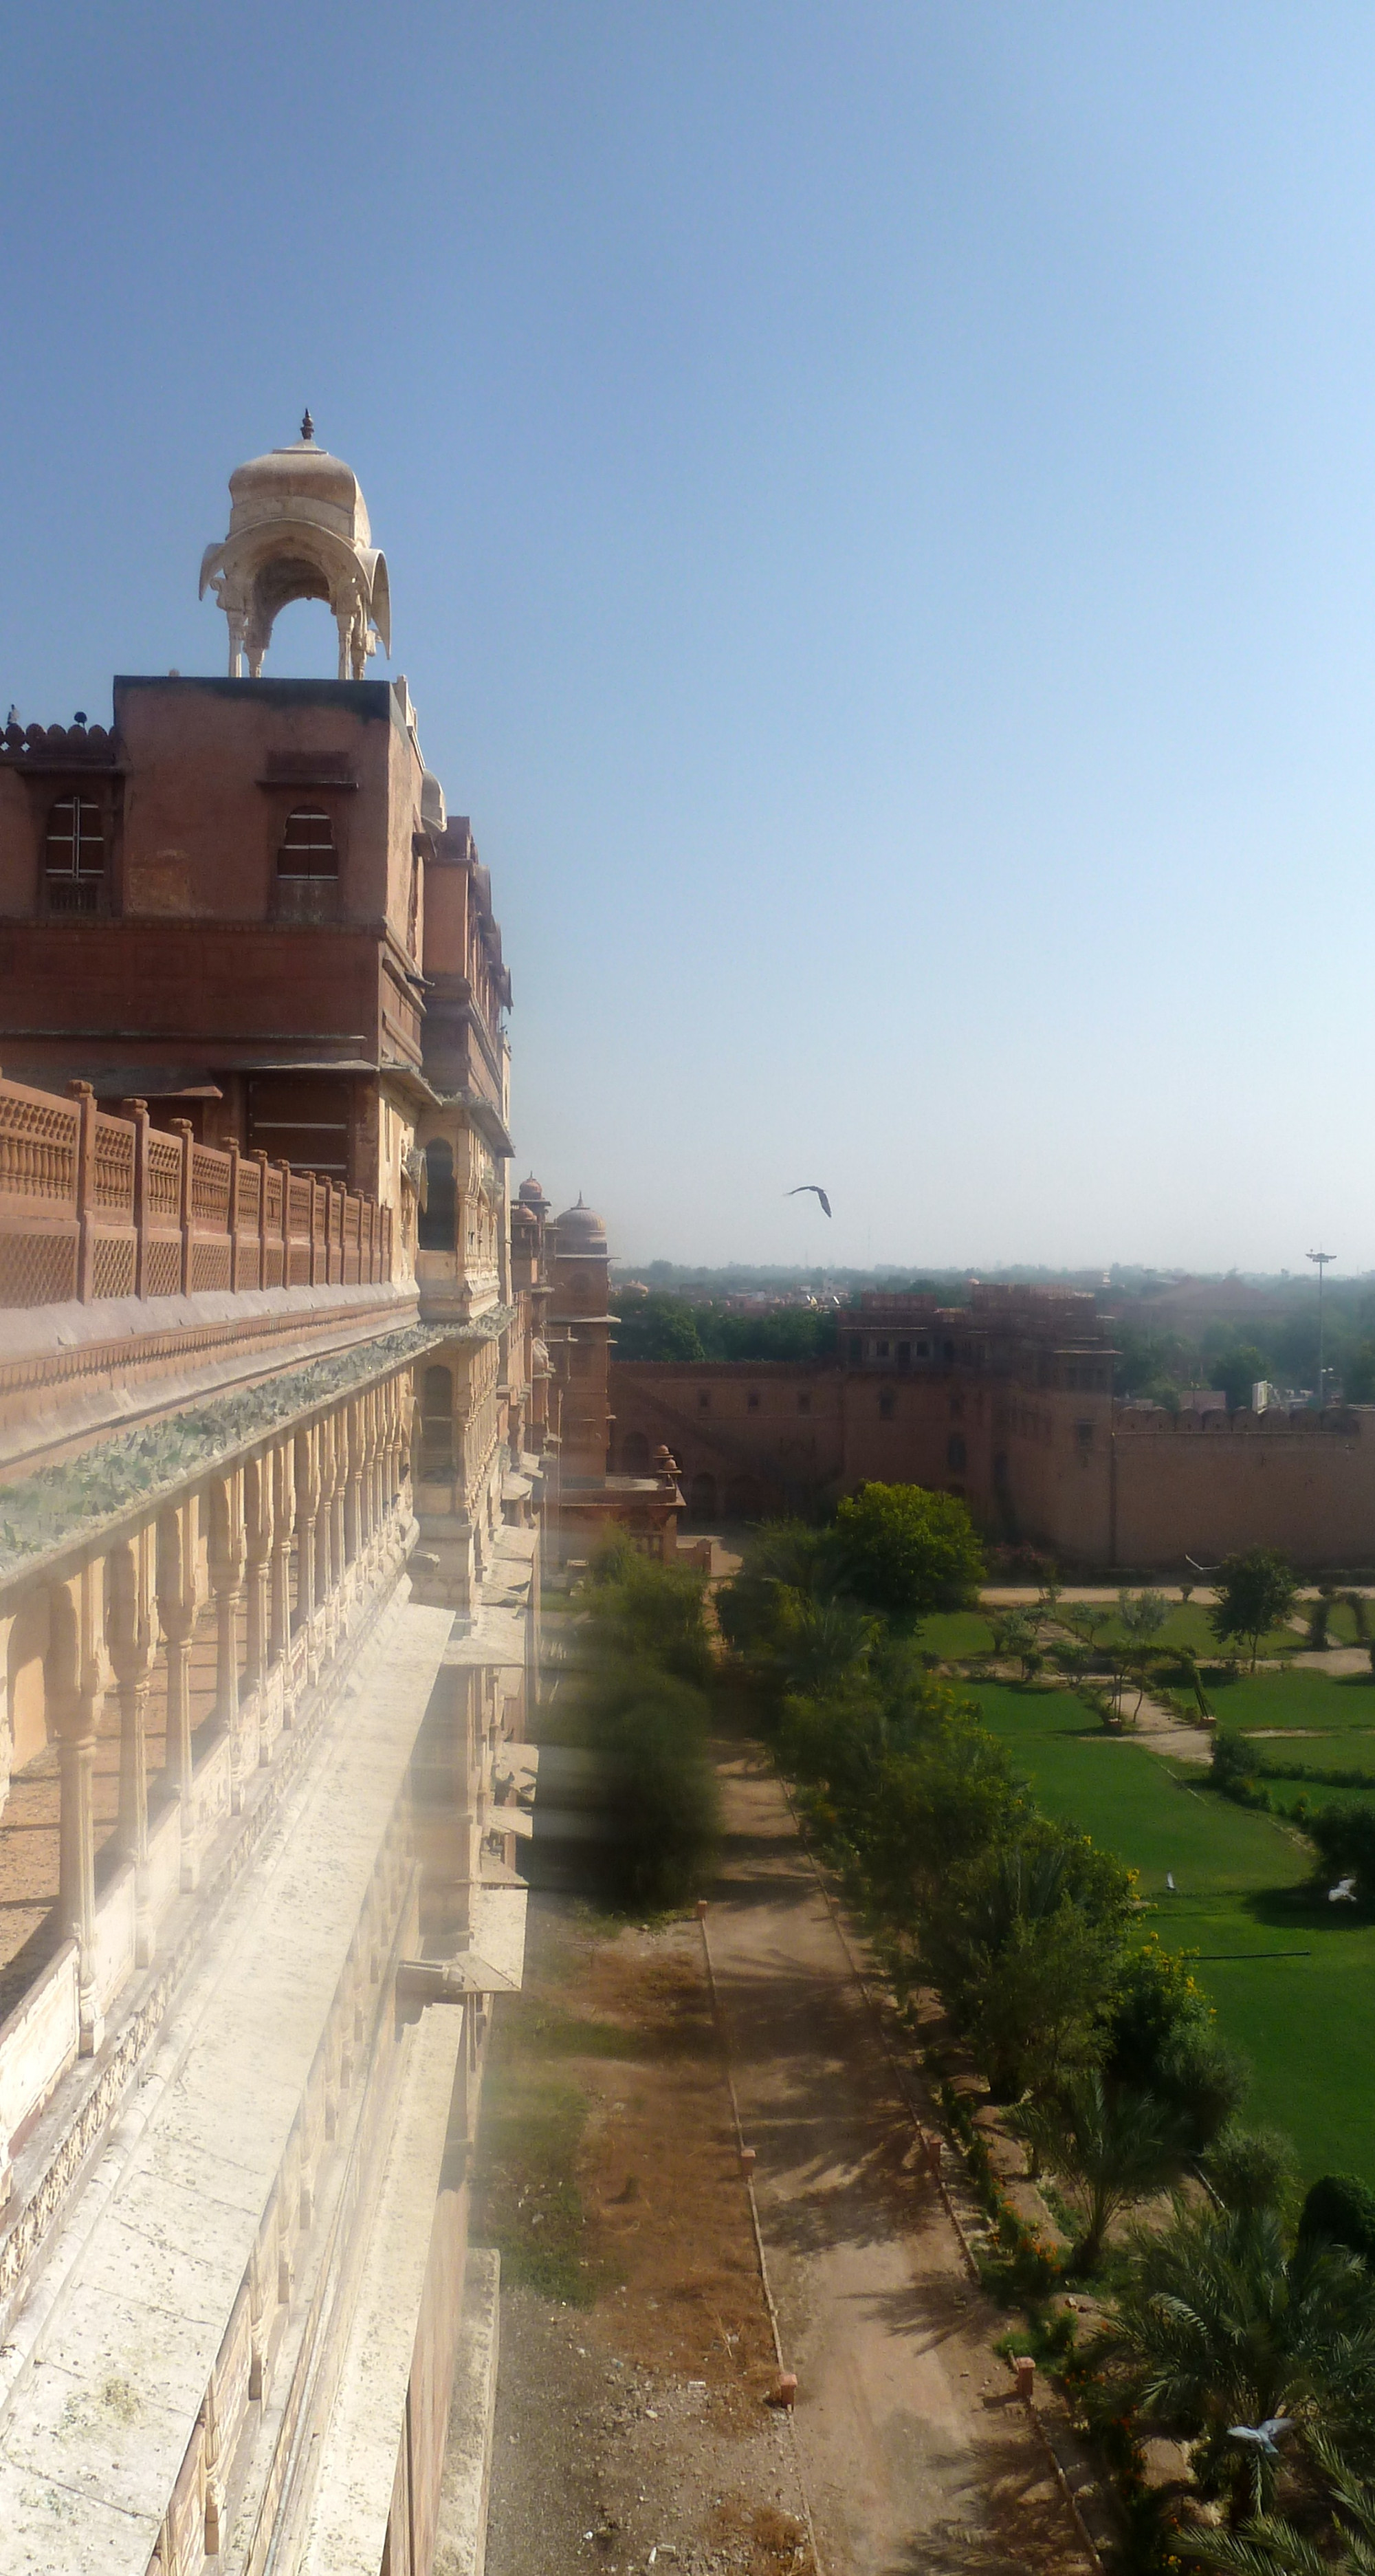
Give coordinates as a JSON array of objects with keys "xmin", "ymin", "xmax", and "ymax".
[{"xmin": 0, "ymin": 422, "xmax": 566, "ymax": 2576}]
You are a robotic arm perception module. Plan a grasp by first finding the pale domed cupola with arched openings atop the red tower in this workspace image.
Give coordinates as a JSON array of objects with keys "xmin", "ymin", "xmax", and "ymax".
[{"xmin": 201, "ymin": 412, "xmax": 391, "ymax": 680}]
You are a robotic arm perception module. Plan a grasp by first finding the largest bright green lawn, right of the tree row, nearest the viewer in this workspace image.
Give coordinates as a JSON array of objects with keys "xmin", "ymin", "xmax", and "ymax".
[{"xmin": 968, "ymin": 1674, "xmax": 1375, "ymax": 2182}]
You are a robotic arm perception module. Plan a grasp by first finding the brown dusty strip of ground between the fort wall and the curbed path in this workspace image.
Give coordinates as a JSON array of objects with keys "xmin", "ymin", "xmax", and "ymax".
[{"xmin": 474, "ymin": 1896, "xmax": 811, "ymax": 2576}]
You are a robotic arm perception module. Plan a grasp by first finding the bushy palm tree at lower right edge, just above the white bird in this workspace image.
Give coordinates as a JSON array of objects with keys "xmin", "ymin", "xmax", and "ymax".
[{"xmin": 1099, "ymin": 2200, "xmax": 1375, "ymax": 2522}]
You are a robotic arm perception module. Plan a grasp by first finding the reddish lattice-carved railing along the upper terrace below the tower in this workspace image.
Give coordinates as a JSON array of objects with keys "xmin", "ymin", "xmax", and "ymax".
[{"xmin": 0, "ymin": 1082, "xmax": 394, "ymax": 1306}]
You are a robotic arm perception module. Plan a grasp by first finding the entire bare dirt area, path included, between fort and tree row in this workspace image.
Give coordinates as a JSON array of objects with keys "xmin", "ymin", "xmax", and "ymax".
[{"xmin": 474, "ymin": 1751, "xmax": 1087, "ymax": 2576}]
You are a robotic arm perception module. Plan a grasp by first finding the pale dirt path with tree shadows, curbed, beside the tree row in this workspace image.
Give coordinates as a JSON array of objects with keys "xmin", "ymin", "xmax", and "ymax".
[{"xmin": 711, "ymin": 1751, "xmax": 1087, "ymax": 2576}]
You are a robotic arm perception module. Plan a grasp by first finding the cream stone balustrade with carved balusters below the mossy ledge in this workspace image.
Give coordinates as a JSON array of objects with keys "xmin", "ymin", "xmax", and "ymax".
[{"xmin": 0, "ymin": 1360, "xmax": 415, "ymax": 2267}]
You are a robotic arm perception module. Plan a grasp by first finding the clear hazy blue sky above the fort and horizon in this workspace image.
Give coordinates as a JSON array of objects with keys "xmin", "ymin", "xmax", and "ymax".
[{"xmin": 0, "ymin": 0, "xmax": 1375, "ymax": 1270}]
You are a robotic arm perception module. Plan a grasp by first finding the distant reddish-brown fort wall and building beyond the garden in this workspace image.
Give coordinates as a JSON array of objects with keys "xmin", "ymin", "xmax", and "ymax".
[{"xmin": 610, "ymin": 1283, "xmax": 1375, "ymax": 1571}]
